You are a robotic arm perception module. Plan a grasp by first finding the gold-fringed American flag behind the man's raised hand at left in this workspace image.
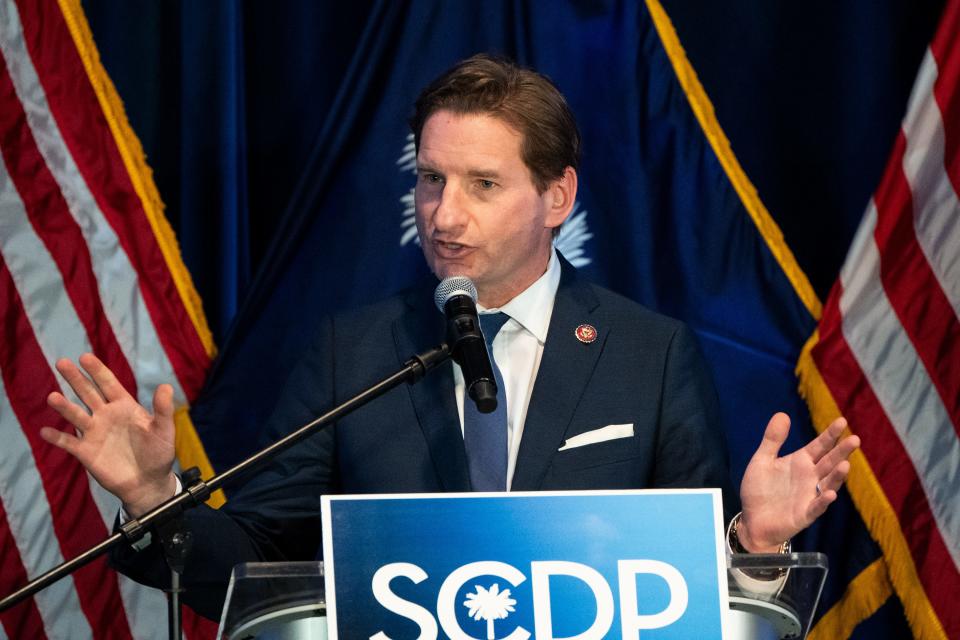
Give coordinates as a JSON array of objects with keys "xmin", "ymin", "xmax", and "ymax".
[{"xmin": 0, "ymin": 0, "xmax": 213, "ymax": 638}]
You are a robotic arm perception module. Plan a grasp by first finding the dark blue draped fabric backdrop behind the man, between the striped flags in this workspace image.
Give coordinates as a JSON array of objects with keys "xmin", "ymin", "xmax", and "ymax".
[{"xmin": 84, "ymin": 0, "xmax": 942, "ymax": 638}]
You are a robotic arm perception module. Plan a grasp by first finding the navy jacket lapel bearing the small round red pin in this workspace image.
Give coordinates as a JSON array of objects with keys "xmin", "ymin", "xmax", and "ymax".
[{"xmin": 511, "ymin": 258, "xmax": 609, "ymax": 491}]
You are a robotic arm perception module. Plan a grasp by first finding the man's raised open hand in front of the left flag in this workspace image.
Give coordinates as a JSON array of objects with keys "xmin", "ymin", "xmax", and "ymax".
[{"xmin": 40, "ymin": 353, "xmax": 176, "ymax": 516}]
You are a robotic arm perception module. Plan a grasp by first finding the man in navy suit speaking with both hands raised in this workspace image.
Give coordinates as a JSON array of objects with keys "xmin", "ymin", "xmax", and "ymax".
[{"xmin": 42, "ymin": 56, "xmax": 858, "ymax": 617}]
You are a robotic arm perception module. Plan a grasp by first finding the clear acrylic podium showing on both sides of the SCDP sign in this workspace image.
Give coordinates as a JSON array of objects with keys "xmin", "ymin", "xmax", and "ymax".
[{"xmin": 217, "ymin": 553, "xmax": 827, "ymax": 640}]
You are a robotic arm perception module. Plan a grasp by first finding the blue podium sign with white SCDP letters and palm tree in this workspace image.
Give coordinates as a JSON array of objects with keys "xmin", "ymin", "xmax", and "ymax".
[{"xmin": 322, "ymin": 489, "xmax": 727, "ymax": 640}]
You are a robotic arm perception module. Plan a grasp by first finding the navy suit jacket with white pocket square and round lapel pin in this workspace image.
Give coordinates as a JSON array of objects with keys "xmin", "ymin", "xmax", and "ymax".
[{"xmin": 114, "ymin": 259, "xmax": 730, "ymax": 618}]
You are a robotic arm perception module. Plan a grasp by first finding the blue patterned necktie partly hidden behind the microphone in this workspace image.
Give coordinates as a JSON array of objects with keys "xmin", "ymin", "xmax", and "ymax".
[{"xmin": 463, "ymin": 312, "xmax": 510, "ymax": 491}]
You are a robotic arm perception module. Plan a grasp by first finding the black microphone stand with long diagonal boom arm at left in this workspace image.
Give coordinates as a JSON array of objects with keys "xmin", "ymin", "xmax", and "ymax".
[{"xmin": 0, "ymin": 343, "xmax": 456, "ymax": 640}]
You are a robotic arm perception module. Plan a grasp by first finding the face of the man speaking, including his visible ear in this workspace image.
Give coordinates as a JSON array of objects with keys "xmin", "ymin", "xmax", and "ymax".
[{"xmin": 415, "ymin": 111, "xmax": 576, "ymax": 307}]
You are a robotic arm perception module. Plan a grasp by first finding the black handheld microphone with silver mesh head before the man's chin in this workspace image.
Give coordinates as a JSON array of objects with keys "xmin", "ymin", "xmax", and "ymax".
[{"xmin": 433, "ymin": 276, "xmax": 497, "ymax": 413}]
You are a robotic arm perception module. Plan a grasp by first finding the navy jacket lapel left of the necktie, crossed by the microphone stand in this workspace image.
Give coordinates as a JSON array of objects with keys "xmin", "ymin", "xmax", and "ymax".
[{"xmin": 393, "ymin": 287, "xmax": 470, "ymax": 491}]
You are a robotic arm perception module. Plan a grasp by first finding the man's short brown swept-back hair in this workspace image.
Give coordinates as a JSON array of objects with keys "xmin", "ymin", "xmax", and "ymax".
[{"xmin": 410, "ymin": 54, "xmax": 580, "ymax": 193}]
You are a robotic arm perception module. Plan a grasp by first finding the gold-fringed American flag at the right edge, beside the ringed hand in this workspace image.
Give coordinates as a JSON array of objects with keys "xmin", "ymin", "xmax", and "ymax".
[{"xmin": 799, "ymin": 0, "xmax": 960, "ymax": 638}]
